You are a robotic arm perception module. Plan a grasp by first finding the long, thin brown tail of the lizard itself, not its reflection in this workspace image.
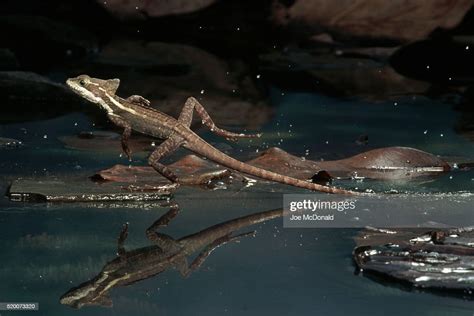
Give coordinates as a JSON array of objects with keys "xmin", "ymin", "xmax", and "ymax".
[{"xmin": 187, "ymin": 139, "xmax": 363, "ymax": 195}]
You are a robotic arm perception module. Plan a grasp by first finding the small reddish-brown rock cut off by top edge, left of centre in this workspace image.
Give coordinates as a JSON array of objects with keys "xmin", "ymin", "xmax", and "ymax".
[{"xmin": 97, "ymin": 0, "xmax": 216, "ymax": 19}]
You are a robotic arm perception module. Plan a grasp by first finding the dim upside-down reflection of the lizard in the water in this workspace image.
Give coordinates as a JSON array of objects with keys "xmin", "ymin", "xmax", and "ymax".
[{"xmin": 60, "ymin": 206, "xmax": 283, "ymax": 308}]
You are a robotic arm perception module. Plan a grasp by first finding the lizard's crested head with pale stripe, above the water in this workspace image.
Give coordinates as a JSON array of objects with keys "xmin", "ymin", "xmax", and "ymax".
[{"xmin": 66, "ymin": 75, "xmax": 120, "ymax": 106}]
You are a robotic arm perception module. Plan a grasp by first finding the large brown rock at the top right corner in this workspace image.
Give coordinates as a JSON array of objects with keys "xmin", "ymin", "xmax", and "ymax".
[{"xmin": 272, "ymin": 0, "xmax": 473, "ymax": 42}]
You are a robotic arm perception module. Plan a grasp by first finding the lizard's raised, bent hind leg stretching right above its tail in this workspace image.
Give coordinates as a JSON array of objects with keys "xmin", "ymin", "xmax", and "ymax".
[{"xmin": 178, "ymin": 97, "xmax": 261, "ymax": 140}]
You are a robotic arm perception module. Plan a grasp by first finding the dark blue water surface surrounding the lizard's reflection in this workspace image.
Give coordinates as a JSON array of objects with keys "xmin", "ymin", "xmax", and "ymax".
[{"xmin": 0, "ymin": 90, "xmax": 474, "ymax": 315}]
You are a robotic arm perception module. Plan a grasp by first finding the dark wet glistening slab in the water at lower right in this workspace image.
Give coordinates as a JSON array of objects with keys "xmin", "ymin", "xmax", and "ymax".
[{"xmin": 353, "ymin": 227, "xmax": 474, "ymax": 296}]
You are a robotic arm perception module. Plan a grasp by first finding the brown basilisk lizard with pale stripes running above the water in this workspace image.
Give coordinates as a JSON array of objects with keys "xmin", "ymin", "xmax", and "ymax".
[{"xmin": 67, "ymin": 75, "xmax": 356, "ymax": 194}]
